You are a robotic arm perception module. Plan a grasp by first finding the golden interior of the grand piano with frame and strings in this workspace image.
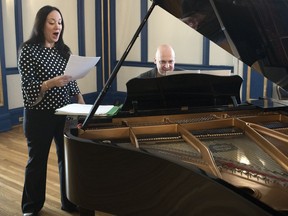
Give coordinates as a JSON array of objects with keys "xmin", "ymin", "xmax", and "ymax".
[{"xmin": 66, "ymin": 109, "xmax": 288, "ymax": 212}]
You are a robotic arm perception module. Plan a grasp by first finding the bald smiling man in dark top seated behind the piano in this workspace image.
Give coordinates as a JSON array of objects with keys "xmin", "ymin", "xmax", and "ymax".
[{"xmin": 138, "ymin": 44, "xmax": 175, "ymax": 78}]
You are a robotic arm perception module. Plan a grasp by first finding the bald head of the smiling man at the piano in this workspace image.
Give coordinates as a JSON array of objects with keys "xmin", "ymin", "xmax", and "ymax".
[{"xmin": 154, "ymin": 44, "xmax": 175, "ymax": 76}]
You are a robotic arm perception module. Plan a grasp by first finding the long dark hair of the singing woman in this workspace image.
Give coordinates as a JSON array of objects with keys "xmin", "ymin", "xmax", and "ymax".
[{"xmin": 22, "ymin": 5, "xmax": 71, "ymax": 59}]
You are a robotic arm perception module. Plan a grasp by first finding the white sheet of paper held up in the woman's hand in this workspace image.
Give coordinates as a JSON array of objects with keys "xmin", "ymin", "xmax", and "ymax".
[{"xmin": 64, "ymin": 55, "xmax": 100, "ymax": 80}]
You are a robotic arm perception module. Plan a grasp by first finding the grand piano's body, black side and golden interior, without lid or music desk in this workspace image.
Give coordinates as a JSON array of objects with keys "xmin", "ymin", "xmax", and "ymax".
[{"xmin": 65, "ymin": 109, "xmax": 288, "ymax": 216}]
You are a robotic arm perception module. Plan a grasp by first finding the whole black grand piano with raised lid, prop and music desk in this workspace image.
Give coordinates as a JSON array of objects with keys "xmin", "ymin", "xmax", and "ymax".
[{"xmin": 65, "ymin": 0, "xmax": 288, "ymax": 216}]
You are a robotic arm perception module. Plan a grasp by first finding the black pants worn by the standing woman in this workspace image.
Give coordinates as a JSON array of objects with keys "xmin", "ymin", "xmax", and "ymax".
[{"xmin": 22, "ymin": 109, "xmax": 73, "ymax": 213}]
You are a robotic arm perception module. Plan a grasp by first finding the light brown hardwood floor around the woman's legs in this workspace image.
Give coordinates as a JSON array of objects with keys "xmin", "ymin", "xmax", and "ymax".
[{"xmin": 0, "ymin": 125, "xmax": 110, "ymax": 216}]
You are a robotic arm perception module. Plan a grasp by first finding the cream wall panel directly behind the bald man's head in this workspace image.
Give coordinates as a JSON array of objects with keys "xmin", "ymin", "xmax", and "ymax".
[{"xmin": 148, "ymin": 6, "xmax": 203, "ymax": 64}]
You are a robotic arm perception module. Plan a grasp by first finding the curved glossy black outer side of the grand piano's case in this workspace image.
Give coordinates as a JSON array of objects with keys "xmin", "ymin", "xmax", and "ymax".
[{"xmin": 65, "ymin": 127, "xmax": 282, "ymax": 216}]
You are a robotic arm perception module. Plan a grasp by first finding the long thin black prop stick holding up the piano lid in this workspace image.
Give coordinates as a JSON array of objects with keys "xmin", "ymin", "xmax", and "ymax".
[{"xmin": 81, "ymin": 1, "xmax": 156, "ymax": 130}]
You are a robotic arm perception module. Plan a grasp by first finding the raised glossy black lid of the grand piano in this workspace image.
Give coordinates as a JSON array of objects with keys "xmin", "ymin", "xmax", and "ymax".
[{"xmin": 154, "ymin": 0, "xmax": 288, "ymax": 90}]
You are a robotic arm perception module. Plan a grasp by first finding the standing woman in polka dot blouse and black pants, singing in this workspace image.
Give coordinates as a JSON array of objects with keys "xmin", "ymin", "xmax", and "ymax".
[{"xmin": 18, "ymin": 6, "xmax": 84, "ymax": 216}]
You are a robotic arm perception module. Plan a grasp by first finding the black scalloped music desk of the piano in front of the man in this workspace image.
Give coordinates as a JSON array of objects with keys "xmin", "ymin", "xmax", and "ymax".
[{"xmin": 122, "ymin": 72, "xmax": 243, "ymax": 112}]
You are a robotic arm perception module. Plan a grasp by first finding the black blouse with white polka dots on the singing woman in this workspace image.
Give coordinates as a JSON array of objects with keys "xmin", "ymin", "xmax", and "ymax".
[{"xmin": 18, "ymin": 44, "xmax": 80, "ymax": 110}]
